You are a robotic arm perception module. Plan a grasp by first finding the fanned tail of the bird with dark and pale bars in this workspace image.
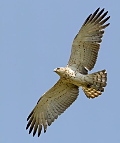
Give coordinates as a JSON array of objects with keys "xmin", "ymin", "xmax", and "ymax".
[{"xmin": 82, "ymin": 70, "xmax": 107, "ymax": 98}]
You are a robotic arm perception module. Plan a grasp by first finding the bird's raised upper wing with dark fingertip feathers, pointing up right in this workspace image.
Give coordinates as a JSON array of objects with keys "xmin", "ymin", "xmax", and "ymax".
[{"xmin": 68, "ymin": 8, "xmax": 110, "ymax": 74}]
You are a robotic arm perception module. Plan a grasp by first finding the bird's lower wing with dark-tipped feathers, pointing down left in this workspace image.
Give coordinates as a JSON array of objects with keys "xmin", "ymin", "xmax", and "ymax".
[{"xmin": 26, "ymin": 79, "xmax": 79, "ymax": 136}]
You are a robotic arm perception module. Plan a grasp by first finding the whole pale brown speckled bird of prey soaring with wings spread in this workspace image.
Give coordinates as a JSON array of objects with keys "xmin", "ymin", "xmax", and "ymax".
[{"xmin": 26, "ymin": 8, "xmax": 110, "ymax": 137}]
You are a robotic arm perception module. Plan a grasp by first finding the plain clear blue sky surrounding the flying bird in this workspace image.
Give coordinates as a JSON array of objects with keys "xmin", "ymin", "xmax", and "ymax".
[{"xmin": 0, "ymin": 0, "xmax": 120, "ymax": 143}]
